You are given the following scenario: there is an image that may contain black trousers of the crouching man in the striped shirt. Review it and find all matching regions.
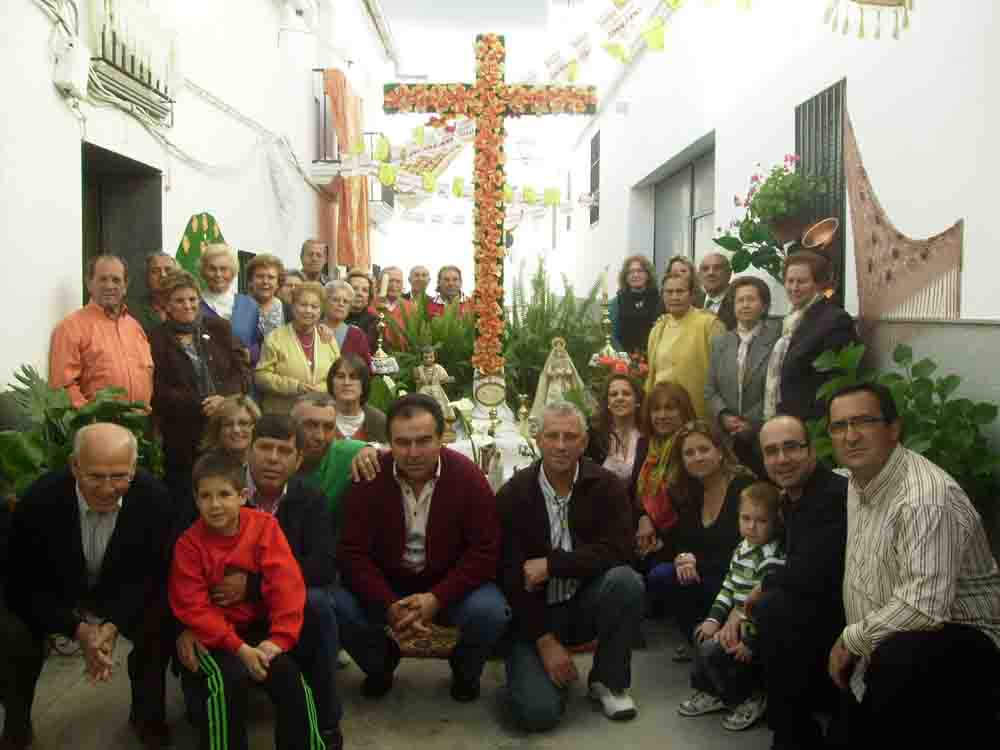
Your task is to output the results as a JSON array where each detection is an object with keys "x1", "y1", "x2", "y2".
[{"x1": 831, "y1": 624, "x2": 1000, "y2": 749}]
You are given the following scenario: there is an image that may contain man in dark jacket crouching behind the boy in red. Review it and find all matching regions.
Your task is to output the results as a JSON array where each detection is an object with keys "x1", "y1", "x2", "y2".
[{"x1": 179, "y1": 414, "x2": 343, "y2": 750}]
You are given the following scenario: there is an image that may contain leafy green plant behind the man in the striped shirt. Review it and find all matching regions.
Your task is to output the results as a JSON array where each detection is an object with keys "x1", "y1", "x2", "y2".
[{"x1": 809, "y1": 344, "x2": 1000, "y2": 504}]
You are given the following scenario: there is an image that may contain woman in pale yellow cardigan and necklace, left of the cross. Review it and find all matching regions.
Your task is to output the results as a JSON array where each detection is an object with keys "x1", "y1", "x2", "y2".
[{"x1": 254, "y1": 282, "x2": 340, "y2": 414}]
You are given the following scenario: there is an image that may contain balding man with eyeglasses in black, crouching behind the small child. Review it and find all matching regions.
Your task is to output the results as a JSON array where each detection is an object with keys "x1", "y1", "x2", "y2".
[{"x1": 746, "y1": 416, "x2": 847, "y2": 750}]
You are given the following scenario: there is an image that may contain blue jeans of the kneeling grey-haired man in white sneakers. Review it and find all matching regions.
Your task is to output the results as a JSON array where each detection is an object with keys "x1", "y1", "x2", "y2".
[{"x1": 507, "y1": 565, "x2": 644, "y2": 732}]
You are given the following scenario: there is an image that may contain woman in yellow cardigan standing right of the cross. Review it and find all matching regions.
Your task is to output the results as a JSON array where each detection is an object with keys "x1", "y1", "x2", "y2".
[{"x1": 646, "y1": 273, "x2": 726, "y2": 419}]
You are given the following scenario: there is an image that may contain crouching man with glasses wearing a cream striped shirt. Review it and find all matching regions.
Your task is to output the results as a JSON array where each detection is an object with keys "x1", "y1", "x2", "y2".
[{"x1": 828, "y1": 384, "x2": 1000, "y2": 747}]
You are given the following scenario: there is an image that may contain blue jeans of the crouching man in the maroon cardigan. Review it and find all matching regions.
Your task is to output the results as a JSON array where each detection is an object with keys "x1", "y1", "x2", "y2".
[{"x1": 334, "y1": 583, "x2": 510, "y2": 682}]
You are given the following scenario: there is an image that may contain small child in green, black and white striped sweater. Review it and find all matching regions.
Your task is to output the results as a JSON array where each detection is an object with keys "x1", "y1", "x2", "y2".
[{"x1": 677, "y1": 482, "x2": 784, "y2": 731}]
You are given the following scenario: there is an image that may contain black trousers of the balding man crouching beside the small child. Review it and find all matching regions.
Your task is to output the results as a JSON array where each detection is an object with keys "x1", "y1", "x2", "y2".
[{"x1": 753, "y1": 589, "x2": 844, "y2": 748}]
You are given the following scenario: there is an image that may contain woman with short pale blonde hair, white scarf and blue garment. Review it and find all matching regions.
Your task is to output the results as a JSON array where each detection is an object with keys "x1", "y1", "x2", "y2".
[{"x1": 199, "y1": 243, "x2": 263, "y2": 364}]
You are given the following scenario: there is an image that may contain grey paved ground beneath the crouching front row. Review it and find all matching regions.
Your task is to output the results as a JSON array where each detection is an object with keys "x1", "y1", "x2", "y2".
[{"x1": 0, "y1": 621, "x2": 770, "y2": 750}]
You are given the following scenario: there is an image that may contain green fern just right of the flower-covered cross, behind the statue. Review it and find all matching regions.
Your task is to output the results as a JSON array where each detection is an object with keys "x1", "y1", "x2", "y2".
[{"x1": 504, "y1": 259, "x2": 604, "y2": 410}]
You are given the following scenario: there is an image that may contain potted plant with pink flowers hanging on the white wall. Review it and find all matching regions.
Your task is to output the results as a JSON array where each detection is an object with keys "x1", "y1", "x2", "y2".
[{"x1": 715, "y1": 154, "x2": 826, "y2": 282}]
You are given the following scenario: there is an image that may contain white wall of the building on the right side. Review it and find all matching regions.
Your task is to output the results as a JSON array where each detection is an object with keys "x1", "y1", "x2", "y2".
[{"x1": 572, "y1": 0, "x2": 1000, "y2": 319}]
